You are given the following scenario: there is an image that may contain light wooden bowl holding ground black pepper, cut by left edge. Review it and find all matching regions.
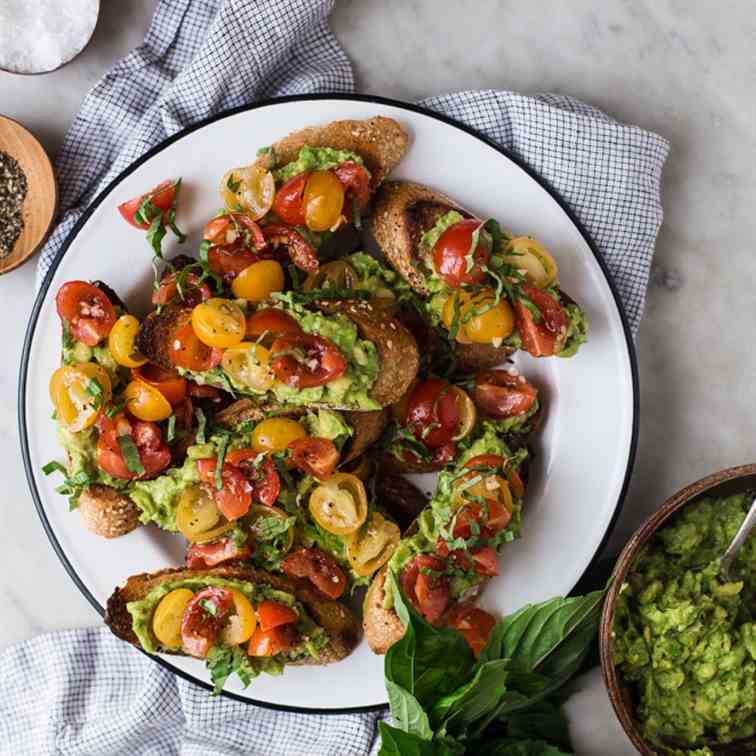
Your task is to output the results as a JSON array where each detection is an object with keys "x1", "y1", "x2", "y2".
[{"x1": 0, "y1": 116, "x2": 58, "y2": 274}]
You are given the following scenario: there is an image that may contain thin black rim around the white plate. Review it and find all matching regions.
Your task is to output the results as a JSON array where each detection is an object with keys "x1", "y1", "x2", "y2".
[{"x1": 18, "y1": 93, "x2": 640, "y2": 714}]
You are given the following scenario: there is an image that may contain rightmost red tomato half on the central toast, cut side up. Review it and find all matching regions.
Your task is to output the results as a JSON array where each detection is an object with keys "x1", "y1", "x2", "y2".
[{"x1": 270, "y1": 333, "x2": 347, "y2": 389}]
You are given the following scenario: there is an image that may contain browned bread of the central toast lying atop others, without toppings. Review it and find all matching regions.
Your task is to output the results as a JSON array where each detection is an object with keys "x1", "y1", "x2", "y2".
[{"x1": 136, "y1": 300, "x2": 420, "y2": 410}]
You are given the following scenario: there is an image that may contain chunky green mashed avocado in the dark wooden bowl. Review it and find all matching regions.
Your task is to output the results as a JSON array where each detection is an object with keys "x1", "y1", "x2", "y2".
[{"x1": 614, "y1": 494, "x2": 756, "y2": 754}]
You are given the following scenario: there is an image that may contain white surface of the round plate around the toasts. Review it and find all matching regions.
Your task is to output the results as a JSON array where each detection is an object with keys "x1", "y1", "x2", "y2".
[{"x1": 19, "y1": 97, "x2": 637, "y2": 711}]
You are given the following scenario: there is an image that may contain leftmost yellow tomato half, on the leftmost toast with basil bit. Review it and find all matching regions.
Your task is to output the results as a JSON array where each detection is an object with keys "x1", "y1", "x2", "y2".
[{"x1": 50, "y1": 362, "x2": 113, "y2": 432}]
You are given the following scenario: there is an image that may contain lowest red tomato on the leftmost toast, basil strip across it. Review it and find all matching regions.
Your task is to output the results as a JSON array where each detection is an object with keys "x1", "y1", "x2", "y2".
[{"x1": 97, "y1": 412, "x2": 171, "y2": 480}]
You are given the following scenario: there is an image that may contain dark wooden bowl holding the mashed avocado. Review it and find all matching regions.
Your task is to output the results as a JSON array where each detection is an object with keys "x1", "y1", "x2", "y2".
[{"x1": 599, "y1": 464, "x2": 756, "y2": 756}]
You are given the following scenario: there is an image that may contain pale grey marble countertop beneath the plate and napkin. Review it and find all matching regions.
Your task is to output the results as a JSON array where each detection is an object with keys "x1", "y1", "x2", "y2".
[{"x1": 0, "y1": 0, "x2": 756, "y2": 756}]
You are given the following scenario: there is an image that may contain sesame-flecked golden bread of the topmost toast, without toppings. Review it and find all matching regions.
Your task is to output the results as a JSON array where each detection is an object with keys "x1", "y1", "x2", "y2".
[{"x1": 255, "y1": 116, "x2": 409, "y2": 191}]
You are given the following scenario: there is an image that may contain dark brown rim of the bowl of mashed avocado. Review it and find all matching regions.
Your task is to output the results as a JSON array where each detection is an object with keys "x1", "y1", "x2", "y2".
[{"x1": 599, "y1": 464, "x2": 756, "y2": 756}]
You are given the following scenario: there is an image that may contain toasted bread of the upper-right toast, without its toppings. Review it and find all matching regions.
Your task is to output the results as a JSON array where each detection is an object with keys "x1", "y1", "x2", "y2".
[{"x1": 369, "y1": 181, "x2": 512, "y2": 370}]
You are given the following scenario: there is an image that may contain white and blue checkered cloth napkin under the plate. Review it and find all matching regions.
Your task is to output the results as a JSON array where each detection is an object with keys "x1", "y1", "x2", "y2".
[{"x1": 13, "y1": 0, "x2": 669, "y2": 756}]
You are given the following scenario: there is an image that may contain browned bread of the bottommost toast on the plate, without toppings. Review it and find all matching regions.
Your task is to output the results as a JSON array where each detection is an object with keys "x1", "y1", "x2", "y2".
[{"x1": 105, "y1": 565, "x2": 359, "y2": 664}]
